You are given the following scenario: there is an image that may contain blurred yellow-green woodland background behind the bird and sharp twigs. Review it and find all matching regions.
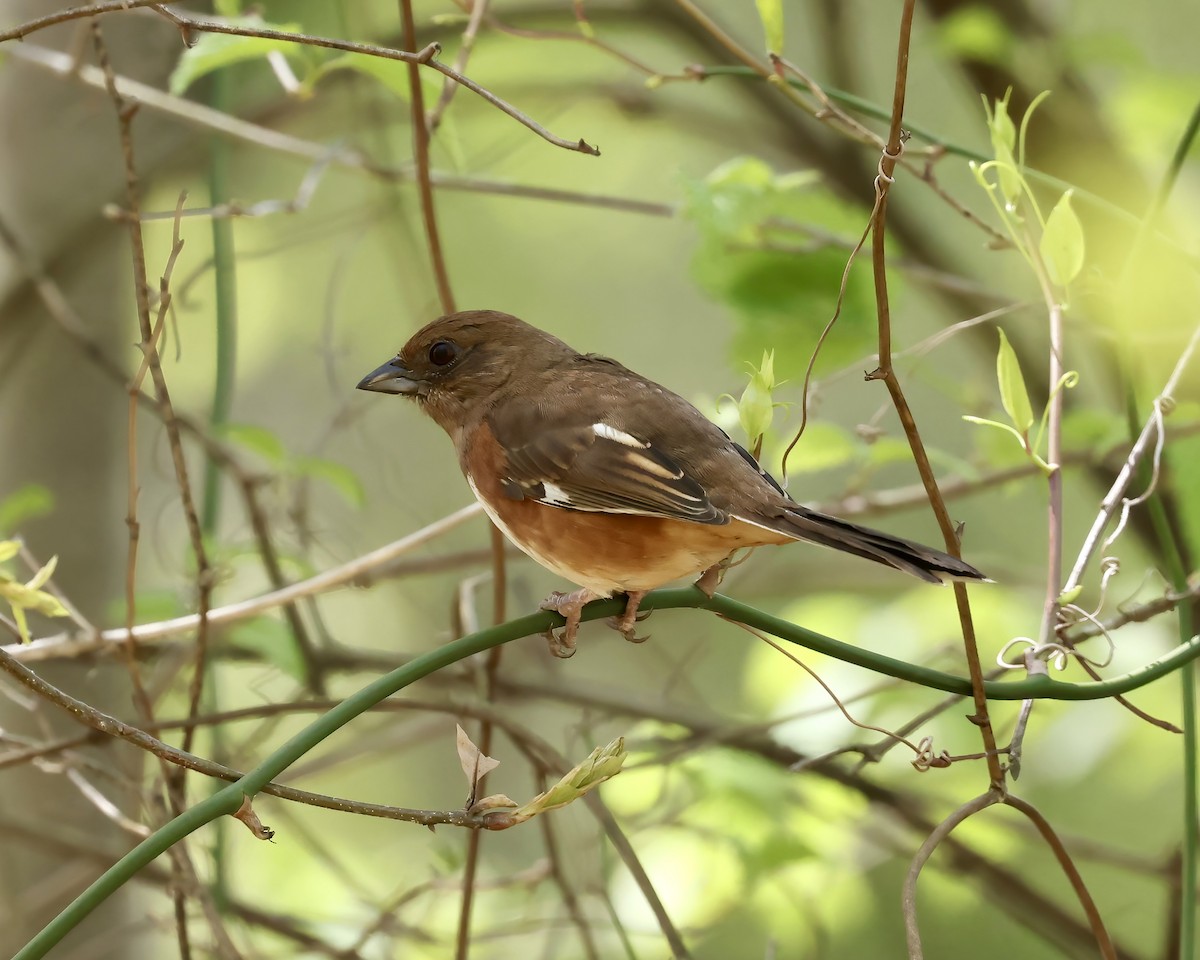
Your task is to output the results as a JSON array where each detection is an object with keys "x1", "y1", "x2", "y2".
[{"x1": 0, "y1": 0, "x2": 1200, "y2": 960}]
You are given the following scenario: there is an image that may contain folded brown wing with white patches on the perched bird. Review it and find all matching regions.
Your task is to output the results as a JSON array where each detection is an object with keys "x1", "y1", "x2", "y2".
[{"x1": 493, "y1": 421, "x2": 728, "y2": 523}]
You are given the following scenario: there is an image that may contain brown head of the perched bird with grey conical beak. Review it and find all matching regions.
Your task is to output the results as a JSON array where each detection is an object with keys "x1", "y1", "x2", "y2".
[{"x1": 359, "y1": 310, "x2": 575, "y2": 433}]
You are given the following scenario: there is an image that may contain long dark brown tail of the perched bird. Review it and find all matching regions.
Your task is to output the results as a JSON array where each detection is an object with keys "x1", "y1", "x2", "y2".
[{"x1": 772, "y1": 506, "x2": 991, "y2": 583}]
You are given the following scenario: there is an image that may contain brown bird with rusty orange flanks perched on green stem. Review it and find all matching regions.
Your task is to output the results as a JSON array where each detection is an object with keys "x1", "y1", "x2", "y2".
[{"x1": 358, "y1": 310, "x2": 988, "y2": 656}]
